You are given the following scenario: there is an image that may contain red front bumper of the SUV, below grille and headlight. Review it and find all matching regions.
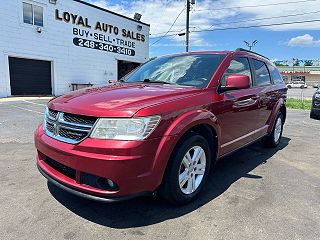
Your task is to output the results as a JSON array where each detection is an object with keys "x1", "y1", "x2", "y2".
[{"x1": 35, "y1": 126, "x2": 168, "y2": 199}]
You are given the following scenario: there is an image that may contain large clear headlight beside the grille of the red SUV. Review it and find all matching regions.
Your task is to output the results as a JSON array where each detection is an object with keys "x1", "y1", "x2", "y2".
[{"x1": 90, "y1": 116, "x2": 161, "y2": 141}]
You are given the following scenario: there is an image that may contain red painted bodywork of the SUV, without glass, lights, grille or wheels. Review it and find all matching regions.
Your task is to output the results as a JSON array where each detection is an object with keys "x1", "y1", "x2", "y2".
[{"x1": 35, "y1": 51, "x2": 287, "y2": 199}]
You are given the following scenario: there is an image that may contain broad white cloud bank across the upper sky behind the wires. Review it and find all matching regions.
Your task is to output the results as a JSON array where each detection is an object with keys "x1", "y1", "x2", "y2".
[{"x1": 87, "y1": 0, "x2": 320, "y2": 49}]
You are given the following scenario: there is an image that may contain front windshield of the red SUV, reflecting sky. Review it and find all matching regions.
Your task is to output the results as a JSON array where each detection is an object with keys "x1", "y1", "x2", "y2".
[{"x1": 121, "y1": 54, "x2": 226, "y2": 88}]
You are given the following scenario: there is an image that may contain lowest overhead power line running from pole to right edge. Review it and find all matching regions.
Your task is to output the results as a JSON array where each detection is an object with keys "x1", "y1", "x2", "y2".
[{"x1": 150, "y1": 19, "x2": 320, "y2": 41}]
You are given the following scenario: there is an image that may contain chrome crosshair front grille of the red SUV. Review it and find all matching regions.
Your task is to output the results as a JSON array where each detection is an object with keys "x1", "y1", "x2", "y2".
[{"x1": 43, "y1": 109, "x2": 97, "y2": 144}]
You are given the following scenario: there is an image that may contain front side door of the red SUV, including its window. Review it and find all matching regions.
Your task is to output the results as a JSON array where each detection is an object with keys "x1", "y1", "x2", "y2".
[{"x1": 214, "y1": 57, "x2": 259, "y2": 155}]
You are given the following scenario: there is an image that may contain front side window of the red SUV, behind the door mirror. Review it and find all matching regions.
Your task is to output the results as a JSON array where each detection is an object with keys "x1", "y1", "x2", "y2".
[{"x1": 220, "y1": 57, "x2": 251, "y2": 86}]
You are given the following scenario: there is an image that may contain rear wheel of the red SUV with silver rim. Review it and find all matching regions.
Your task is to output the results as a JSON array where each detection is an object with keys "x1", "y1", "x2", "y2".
[{"x1": 262, "y1": 112, "x2": 284, "y2": 148}]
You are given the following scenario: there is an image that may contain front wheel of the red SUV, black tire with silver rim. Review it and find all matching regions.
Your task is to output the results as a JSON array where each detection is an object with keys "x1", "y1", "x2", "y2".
[{"x1": 160, "y1": 134, "x2": 211, "y2": 205}]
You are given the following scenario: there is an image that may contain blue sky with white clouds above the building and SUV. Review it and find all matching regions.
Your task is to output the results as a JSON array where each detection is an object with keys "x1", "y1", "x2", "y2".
[{"x1": 86, "y1": 0, "x2": 320, "y2": 60}]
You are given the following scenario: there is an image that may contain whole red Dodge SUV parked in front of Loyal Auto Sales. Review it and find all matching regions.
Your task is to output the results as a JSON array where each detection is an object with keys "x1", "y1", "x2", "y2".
[{"x1": 35, "y1": 49, "x2": 287, "y2": 204}]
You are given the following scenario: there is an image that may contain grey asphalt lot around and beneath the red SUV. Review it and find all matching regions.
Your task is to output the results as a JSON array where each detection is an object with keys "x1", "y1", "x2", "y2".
[{"x1": 0, "y1": 100, "x2": 320, "y2": 240}]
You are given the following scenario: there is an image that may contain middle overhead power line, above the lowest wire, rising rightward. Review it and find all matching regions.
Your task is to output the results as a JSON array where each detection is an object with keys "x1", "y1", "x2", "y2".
[{"x1": 150, "y1": 11, "x2": 320, "y2": 38}]
